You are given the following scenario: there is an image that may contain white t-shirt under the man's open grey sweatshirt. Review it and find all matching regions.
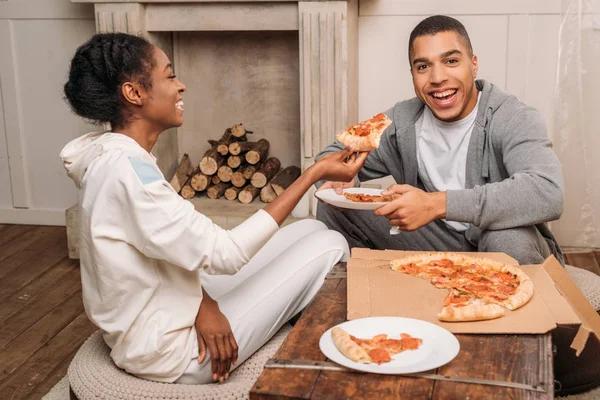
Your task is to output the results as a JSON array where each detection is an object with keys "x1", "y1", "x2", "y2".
[{"x1": 416, "y1": 93, "x2": 481, "y2": 232}]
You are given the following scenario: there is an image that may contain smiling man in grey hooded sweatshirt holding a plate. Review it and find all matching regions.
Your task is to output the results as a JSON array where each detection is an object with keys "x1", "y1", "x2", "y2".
[{"x1": 316, "y1": 16, "x2": 564, "y2": 264}]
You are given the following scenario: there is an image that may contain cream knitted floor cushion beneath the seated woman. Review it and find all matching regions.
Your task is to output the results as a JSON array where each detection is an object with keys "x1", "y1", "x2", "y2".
[{"x1": 68, "y1": 324, "x2": 292, "y2": 400}]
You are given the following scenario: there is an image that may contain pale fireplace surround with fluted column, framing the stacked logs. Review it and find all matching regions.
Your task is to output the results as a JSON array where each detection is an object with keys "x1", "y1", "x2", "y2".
[{"x1": 71, "y1": 0, "x2": 358, "y2": 217}]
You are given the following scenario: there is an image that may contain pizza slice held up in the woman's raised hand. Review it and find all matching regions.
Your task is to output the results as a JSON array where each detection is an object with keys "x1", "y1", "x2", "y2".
[{"x1": 336, "y1": 114, "x2": 392, "y2": 151}]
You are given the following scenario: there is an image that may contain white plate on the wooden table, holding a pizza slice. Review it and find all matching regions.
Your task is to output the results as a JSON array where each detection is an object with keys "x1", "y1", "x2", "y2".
[{"x1": 319, "y1": 317, "x2": 460, "y2": 374}]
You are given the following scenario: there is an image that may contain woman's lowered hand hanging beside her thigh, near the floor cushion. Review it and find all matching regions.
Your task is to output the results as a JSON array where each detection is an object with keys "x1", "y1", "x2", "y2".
[{"x1": 195, "y1": 289, "x2": 238, "y2": 382}]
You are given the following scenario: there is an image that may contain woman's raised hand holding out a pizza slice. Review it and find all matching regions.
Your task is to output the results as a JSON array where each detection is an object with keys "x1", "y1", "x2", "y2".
[{"x1": 311, "y1": 147, "x2": 369, "y2": 182}]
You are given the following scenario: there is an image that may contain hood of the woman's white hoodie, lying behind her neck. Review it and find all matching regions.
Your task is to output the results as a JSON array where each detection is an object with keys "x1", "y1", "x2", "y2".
[{"x1": 60, "y1": 132, "x2": 148, "y2": 188}]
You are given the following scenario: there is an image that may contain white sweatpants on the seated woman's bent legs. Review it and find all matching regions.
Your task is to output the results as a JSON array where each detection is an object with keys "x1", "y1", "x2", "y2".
[{"x1": 176, "y1": 220, "x2": 349, "y2": 384}]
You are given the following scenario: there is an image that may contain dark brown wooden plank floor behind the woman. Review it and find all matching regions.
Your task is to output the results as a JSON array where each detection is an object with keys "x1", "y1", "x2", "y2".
[{"x1": 0, "y1": 225, "x2": 600, "y2": 400}]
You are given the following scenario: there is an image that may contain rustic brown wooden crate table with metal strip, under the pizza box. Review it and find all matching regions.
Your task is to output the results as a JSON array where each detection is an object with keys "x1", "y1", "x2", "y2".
[{"x1": 250, "y1": 264, "x2": 554, "y2": 400}]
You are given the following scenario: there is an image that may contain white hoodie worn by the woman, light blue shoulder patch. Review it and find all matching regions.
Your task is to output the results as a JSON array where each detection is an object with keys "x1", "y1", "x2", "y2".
[{"x1": 60, "y1": 132, "x2": 279, "y2": 382}]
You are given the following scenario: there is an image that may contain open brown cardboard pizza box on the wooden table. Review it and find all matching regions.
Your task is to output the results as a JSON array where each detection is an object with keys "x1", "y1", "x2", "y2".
[{"x1": 347, "y1": 248, "x2": 600, "y2": 353}]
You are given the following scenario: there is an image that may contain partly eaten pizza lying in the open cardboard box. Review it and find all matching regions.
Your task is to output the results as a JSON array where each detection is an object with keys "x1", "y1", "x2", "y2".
[{"x1": 391, "y1": 253, "x2": 533, "y2": 322}]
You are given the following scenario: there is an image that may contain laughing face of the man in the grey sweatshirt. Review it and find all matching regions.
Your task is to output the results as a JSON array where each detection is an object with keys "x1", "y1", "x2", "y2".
[{"x1": 410, "y1": 32, "x2": 478, "y2": 122}]
